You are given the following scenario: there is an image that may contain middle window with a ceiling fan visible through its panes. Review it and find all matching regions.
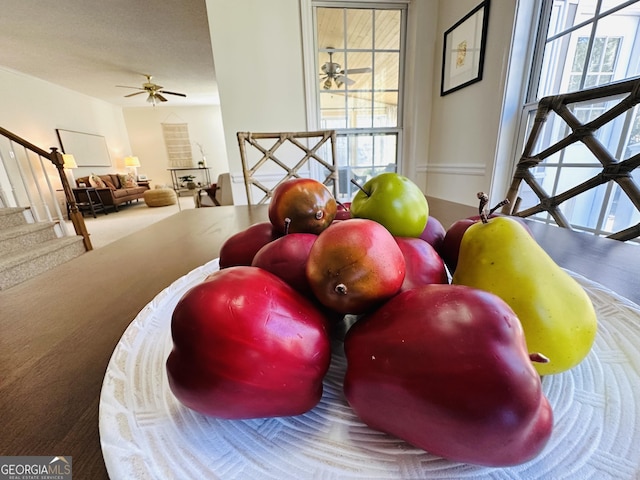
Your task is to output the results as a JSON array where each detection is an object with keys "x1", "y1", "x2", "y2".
[{"x1": 309, "y1": 1, "x2": 406, "y2": 201}]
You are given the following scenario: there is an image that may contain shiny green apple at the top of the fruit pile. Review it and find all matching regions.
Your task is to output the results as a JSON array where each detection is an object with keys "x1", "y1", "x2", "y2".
[{"x1": 351, "y1": 172, "x2": 429, "y2": 237}]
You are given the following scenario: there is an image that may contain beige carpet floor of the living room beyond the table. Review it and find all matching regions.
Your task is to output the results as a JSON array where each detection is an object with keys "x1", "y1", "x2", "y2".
[{"x1": 66, "y1": 197, "x2": 195, "y2": 249}]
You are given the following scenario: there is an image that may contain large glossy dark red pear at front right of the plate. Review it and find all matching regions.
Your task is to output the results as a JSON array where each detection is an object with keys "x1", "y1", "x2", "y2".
[{"x1": 344, "y1": 285, "x2": 553, "y2": 467}]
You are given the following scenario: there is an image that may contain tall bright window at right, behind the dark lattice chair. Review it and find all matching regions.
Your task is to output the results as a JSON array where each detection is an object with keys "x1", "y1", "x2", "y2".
[{"x1": 519, "y1": 0, "x2": 640, "y2": 240}]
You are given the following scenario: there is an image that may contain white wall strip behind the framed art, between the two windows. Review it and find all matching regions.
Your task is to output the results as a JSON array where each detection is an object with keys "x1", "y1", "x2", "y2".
[{"x1": 425, "y1": 0, "x2": 517, "y2": 205}]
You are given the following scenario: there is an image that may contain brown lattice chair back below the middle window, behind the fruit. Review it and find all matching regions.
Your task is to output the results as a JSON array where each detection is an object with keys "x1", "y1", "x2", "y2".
[{"x1": 237, "y1": 130, "x2": 338, "y2": 204}]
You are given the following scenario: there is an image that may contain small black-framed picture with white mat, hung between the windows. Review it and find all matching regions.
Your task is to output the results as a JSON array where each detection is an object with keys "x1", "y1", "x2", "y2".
[{"x1": 440, "y1": 0, "x2": 490, "y2": 96}]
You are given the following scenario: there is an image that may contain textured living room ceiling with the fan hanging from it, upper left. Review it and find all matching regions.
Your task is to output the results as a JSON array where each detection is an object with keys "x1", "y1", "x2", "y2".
[{"x1": 0, "y1": 0, "x2": 218, "y2": 107}]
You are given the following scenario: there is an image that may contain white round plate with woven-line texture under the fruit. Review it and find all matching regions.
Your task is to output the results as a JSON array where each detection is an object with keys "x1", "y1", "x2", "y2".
[{"x1": 99, "y1": 260, "x2": 640, "y2": 480}]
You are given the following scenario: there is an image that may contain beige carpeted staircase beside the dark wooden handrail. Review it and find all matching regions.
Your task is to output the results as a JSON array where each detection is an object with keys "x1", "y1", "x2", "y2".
[{"x1": 0, "y1": 207, "x2": 86, "y2": 290}]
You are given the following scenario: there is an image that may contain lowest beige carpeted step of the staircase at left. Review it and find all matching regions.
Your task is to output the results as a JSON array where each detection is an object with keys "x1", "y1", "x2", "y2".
[{"x1": 0, "y1": 235, "x2": 85, "y2": 290}]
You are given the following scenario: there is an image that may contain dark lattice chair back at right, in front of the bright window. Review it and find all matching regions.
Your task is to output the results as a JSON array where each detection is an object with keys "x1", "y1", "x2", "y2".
[{"x1": 502, "y1": 78, "x2": 640, "y2": 241}]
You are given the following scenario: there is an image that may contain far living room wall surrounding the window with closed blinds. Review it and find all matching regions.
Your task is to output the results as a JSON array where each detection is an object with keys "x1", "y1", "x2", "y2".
[{"x1": 124, "y1": 105, "x2": 229, "y2": 186}]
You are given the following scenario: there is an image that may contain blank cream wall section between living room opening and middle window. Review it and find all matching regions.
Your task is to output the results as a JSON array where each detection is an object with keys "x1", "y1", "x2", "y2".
[{"x1": 207, "y1": 0, "x2": 306, "y2": 204}]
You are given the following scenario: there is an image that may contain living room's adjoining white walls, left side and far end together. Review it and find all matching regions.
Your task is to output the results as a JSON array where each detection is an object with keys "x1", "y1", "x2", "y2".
[{"x1": 0, "y1": 67, "x2": 229, "y2": 197}]
